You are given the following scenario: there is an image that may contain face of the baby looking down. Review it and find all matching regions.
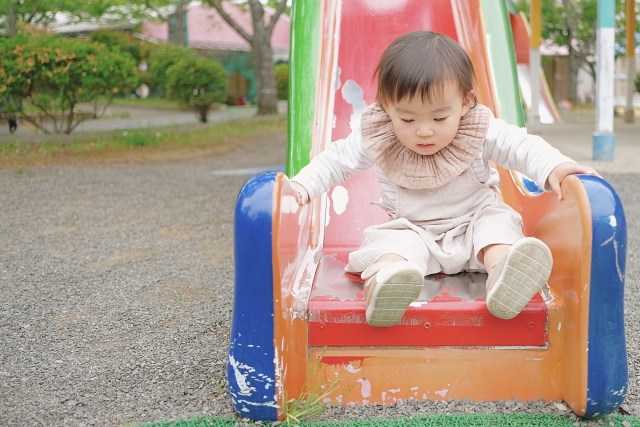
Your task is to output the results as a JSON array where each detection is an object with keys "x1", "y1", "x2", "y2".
[{"x1": 383, "y1": 84, "x2": 475, "y2": 155}]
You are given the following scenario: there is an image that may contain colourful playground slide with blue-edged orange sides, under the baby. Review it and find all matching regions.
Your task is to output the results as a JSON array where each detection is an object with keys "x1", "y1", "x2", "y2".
[{"x1": 228, "y1": 0, "x2": 627, "y2": 420}]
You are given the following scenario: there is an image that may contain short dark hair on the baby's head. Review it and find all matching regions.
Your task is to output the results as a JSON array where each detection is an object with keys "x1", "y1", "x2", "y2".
[{"x1": 374, "y1": 31, "x2": 476, "y2": 104}]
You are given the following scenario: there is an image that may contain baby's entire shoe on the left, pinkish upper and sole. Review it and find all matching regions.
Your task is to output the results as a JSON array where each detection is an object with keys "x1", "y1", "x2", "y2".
[{"x1": 362, "y1": 254, "x2": 424, "y2": 326}]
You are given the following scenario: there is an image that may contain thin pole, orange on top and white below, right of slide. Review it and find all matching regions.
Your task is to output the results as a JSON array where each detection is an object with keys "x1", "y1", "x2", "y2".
[{"x1": 527, "y1": 0, "x2": 542, "y2": 133}]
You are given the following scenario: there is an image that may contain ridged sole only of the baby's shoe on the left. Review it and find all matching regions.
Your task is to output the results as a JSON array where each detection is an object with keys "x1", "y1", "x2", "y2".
[{"x1": 366, "y1": 262, "x2": 424, "y2": 326}]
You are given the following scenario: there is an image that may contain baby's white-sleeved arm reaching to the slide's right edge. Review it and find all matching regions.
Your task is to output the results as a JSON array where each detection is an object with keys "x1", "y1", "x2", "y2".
[{"x1": 482, "y1": 117, "x2": 599, "y2": 197}]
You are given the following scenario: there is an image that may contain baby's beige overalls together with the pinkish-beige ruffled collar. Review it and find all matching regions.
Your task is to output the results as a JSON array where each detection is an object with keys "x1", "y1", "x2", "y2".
[{"x1": 345, "y1": 106, "x2": 524, "y2": 275}]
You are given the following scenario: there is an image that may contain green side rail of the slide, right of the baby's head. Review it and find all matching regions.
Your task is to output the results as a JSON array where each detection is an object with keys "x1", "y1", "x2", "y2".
[{"x1": 480, "y1": 0, "x2": 524, "y2": 126}]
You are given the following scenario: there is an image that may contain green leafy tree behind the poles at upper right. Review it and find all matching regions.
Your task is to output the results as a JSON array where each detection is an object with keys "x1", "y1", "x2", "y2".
[{"x1": 516, "y1": 0, "x2": 638, "y2": 102}]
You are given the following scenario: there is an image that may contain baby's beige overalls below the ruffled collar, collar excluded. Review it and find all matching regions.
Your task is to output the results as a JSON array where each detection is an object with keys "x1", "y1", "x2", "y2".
[{"x1": 346, "y1": 169, "x2": 524, "y2": 275}]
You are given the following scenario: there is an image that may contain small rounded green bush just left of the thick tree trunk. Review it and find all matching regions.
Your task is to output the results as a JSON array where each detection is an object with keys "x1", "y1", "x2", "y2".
[{"x1": 167, "y1": 58, "x2": 229, "y2": 122}]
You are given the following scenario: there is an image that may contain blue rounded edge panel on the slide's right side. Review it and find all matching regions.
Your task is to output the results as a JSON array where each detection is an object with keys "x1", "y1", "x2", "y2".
[{"x1": 579, "y1": 175, "x2": 628, "y2": 417}]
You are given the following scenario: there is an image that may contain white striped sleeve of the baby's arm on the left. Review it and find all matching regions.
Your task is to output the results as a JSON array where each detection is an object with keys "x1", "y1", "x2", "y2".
[{"x1": 291, "y1": 128, "x2": 373, "y2": 206}]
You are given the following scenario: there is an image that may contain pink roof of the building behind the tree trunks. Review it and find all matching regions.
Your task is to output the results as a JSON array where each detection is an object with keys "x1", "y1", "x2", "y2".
[{"x1": 142, "y1": 2, "x2": 291, "y2": 60}]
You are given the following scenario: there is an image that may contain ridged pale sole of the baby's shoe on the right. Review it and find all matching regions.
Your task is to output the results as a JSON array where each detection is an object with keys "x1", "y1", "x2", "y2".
[{"x1": 487, "y1": 237, "x2": 553, "y2": 319}]
